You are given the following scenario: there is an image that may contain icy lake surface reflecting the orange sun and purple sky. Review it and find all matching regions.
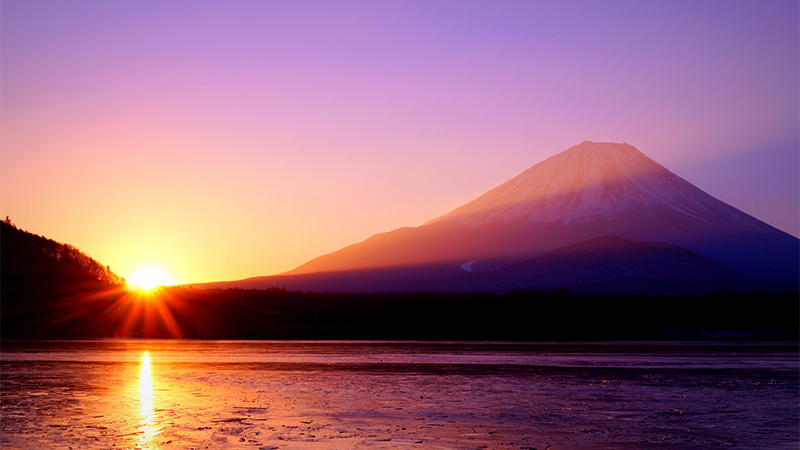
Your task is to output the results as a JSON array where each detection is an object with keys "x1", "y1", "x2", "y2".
[{"x1": 0, "y1": 340, "x2": 800, "y2": 450}]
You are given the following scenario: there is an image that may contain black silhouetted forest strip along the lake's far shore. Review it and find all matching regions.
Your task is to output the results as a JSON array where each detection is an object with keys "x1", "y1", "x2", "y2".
[{"x1": 2, "y1": 287, "x2": 800, "y2": 341}]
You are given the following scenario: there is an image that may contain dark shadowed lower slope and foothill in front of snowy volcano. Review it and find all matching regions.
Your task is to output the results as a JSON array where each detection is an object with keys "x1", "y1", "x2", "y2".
[{"x1": 188, "y1": 236, "x2": 780, "y2": 296}]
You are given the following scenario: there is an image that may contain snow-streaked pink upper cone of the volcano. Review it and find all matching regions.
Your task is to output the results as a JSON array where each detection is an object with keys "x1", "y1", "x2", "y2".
[{"x1": 427, "y1": 141, "x2": 752, "y2": 228}]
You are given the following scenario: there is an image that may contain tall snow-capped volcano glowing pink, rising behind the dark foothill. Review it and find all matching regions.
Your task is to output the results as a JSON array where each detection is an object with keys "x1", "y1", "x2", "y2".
[{"x1": 197, "y1": 142, "x2": 800, "y2": 291}]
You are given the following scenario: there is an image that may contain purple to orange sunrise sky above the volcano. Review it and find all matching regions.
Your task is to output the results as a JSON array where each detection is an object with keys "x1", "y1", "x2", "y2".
[{"x1": 0, "y1": 0, "x2": 800, "y2": 283}]
